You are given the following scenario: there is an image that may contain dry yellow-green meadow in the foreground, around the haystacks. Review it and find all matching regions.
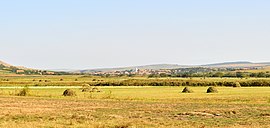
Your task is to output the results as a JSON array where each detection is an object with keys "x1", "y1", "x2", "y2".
[{"x1": 0, "y1": 86, "x2": 270, "y2": 128}]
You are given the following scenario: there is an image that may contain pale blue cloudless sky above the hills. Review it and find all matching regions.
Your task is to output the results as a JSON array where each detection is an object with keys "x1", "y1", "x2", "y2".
[{"x1": 0, "y1": 0, "x2": 270, "y2": 69}]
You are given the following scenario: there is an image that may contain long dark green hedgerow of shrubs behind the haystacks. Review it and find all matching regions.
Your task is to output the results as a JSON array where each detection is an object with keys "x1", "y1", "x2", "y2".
[{"x1": 85, "y1": 79, "x2": 270, "y2": 87}]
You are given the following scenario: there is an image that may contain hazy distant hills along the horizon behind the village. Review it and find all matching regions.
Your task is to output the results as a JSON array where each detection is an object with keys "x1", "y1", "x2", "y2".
[{"x1": 0, "y1": 61, "x2": 270, "y2": 75}]
